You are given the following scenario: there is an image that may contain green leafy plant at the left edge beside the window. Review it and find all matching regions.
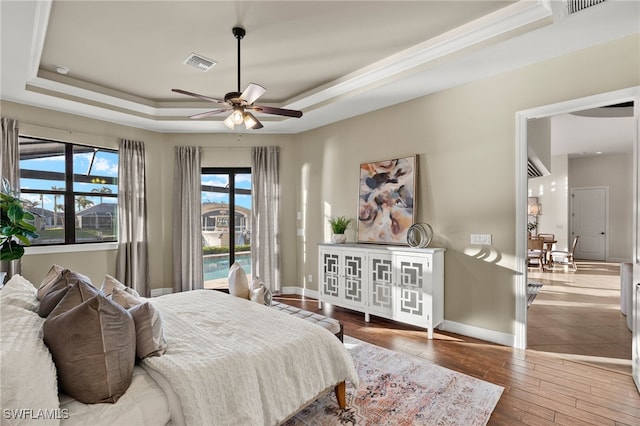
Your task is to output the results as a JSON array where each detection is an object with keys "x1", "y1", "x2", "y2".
[{"x1": 0, "y1": 179, "x2": 38, "y2": 284}]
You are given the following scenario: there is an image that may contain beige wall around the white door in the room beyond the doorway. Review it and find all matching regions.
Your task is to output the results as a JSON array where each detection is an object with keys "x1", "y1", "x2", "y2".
[{"x1": 569, "y1": 153, "x2": 633, "y2": 262}]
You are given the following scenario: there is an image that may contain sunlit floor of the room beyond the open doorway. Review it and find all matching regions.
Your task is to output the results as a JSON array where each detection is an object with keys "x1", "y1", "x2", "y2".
[{"x1": 527, "y1": 261, "x2": 631, "y2": 374}]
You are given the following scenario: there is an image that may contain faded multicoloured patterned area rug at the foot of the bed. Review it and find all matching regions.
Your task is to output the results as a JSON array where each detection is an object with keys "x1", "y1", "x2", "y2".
[{"x1": 285, "y1": 336, "x2": 504, "y2": 426}]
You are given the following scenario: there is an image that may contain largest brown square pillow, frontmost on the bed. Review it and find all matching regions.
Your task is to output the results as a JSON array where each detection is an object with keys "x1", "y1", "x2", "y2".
[{"x1": 44, "y1": 294, "x2": 136, "y2": 404}]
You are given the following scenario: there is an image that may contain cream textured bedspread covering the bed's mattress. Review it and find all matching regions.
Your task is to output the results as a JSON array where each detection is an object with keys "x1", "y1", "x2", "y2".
[{"x1": 142, "y1": 290, "x2": 358, "y2": 425}]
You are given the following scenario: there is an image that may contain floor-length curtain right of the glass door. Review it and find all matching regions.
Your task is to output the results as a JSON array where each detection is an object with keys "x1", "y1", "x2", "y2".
[{"x1": 251, "y1": 146, "x2": 282, "y2": 294}]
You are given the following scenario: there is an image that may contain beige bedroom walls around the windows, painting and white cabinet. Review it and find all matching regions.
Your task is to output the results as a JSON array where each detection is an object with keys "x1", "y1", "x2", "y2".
[{"x1": 1, "y1": 35, "x2": 640, "y2": 335}]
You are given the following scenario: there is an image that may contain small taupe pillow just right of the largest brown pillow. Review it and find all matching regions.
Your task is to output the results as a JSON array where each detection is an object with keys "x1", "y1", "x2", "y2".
[{"x1": 129, "y1": 302, "x2": 167, "y2": 359}]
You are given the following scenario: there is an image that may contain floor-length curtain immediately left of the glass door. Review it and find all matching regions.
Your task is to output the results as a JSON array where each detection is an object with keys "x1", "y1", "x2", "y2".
[{"x1": 173, "y1": 146, "x2": 204, "y2": 293}]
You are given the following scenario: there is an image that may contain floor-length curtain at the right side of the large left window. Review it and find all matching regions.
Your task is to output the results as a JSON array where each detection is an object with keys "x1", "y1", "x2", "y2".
[{"x1": 116, "y1": 139, "x2": 151, "y2": 297}]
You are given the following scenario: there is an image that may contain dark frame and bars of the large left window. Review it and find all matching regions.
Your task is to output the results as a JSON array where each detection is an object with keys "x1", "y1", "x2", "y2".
[{"x1": 19, "y1": 134, "x2": 120, "y2": 248}]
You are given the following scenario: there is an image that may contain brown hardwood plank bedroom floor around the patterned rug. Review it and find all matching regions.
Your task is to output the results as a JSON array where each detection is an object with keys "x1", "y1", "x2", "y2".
[{"x1": 275, "y1": 276, "x2": 640, "y2": 426}]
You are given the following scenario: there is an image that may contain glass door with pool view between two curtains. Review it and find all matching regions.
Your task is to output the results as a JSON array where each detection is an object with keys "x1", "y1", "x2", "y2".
[{"x1": 201, "y1": 167, "x2": 251, "y2": 289}]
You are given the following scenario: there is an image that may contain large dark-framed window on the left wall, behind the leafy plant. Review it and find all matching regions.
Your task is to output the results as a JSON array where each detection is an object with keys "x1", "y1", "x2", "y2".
[{"x1": 19, "y1": 136, "x2": 118, "y2": 245}]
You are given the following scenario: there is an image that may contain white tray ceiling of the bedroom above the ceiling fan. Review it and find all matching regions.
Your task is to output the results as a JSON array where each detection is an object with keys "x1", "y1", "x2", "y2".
[{"x1": 0, "y1": 0, "x2": 640, "y2": 155}]
